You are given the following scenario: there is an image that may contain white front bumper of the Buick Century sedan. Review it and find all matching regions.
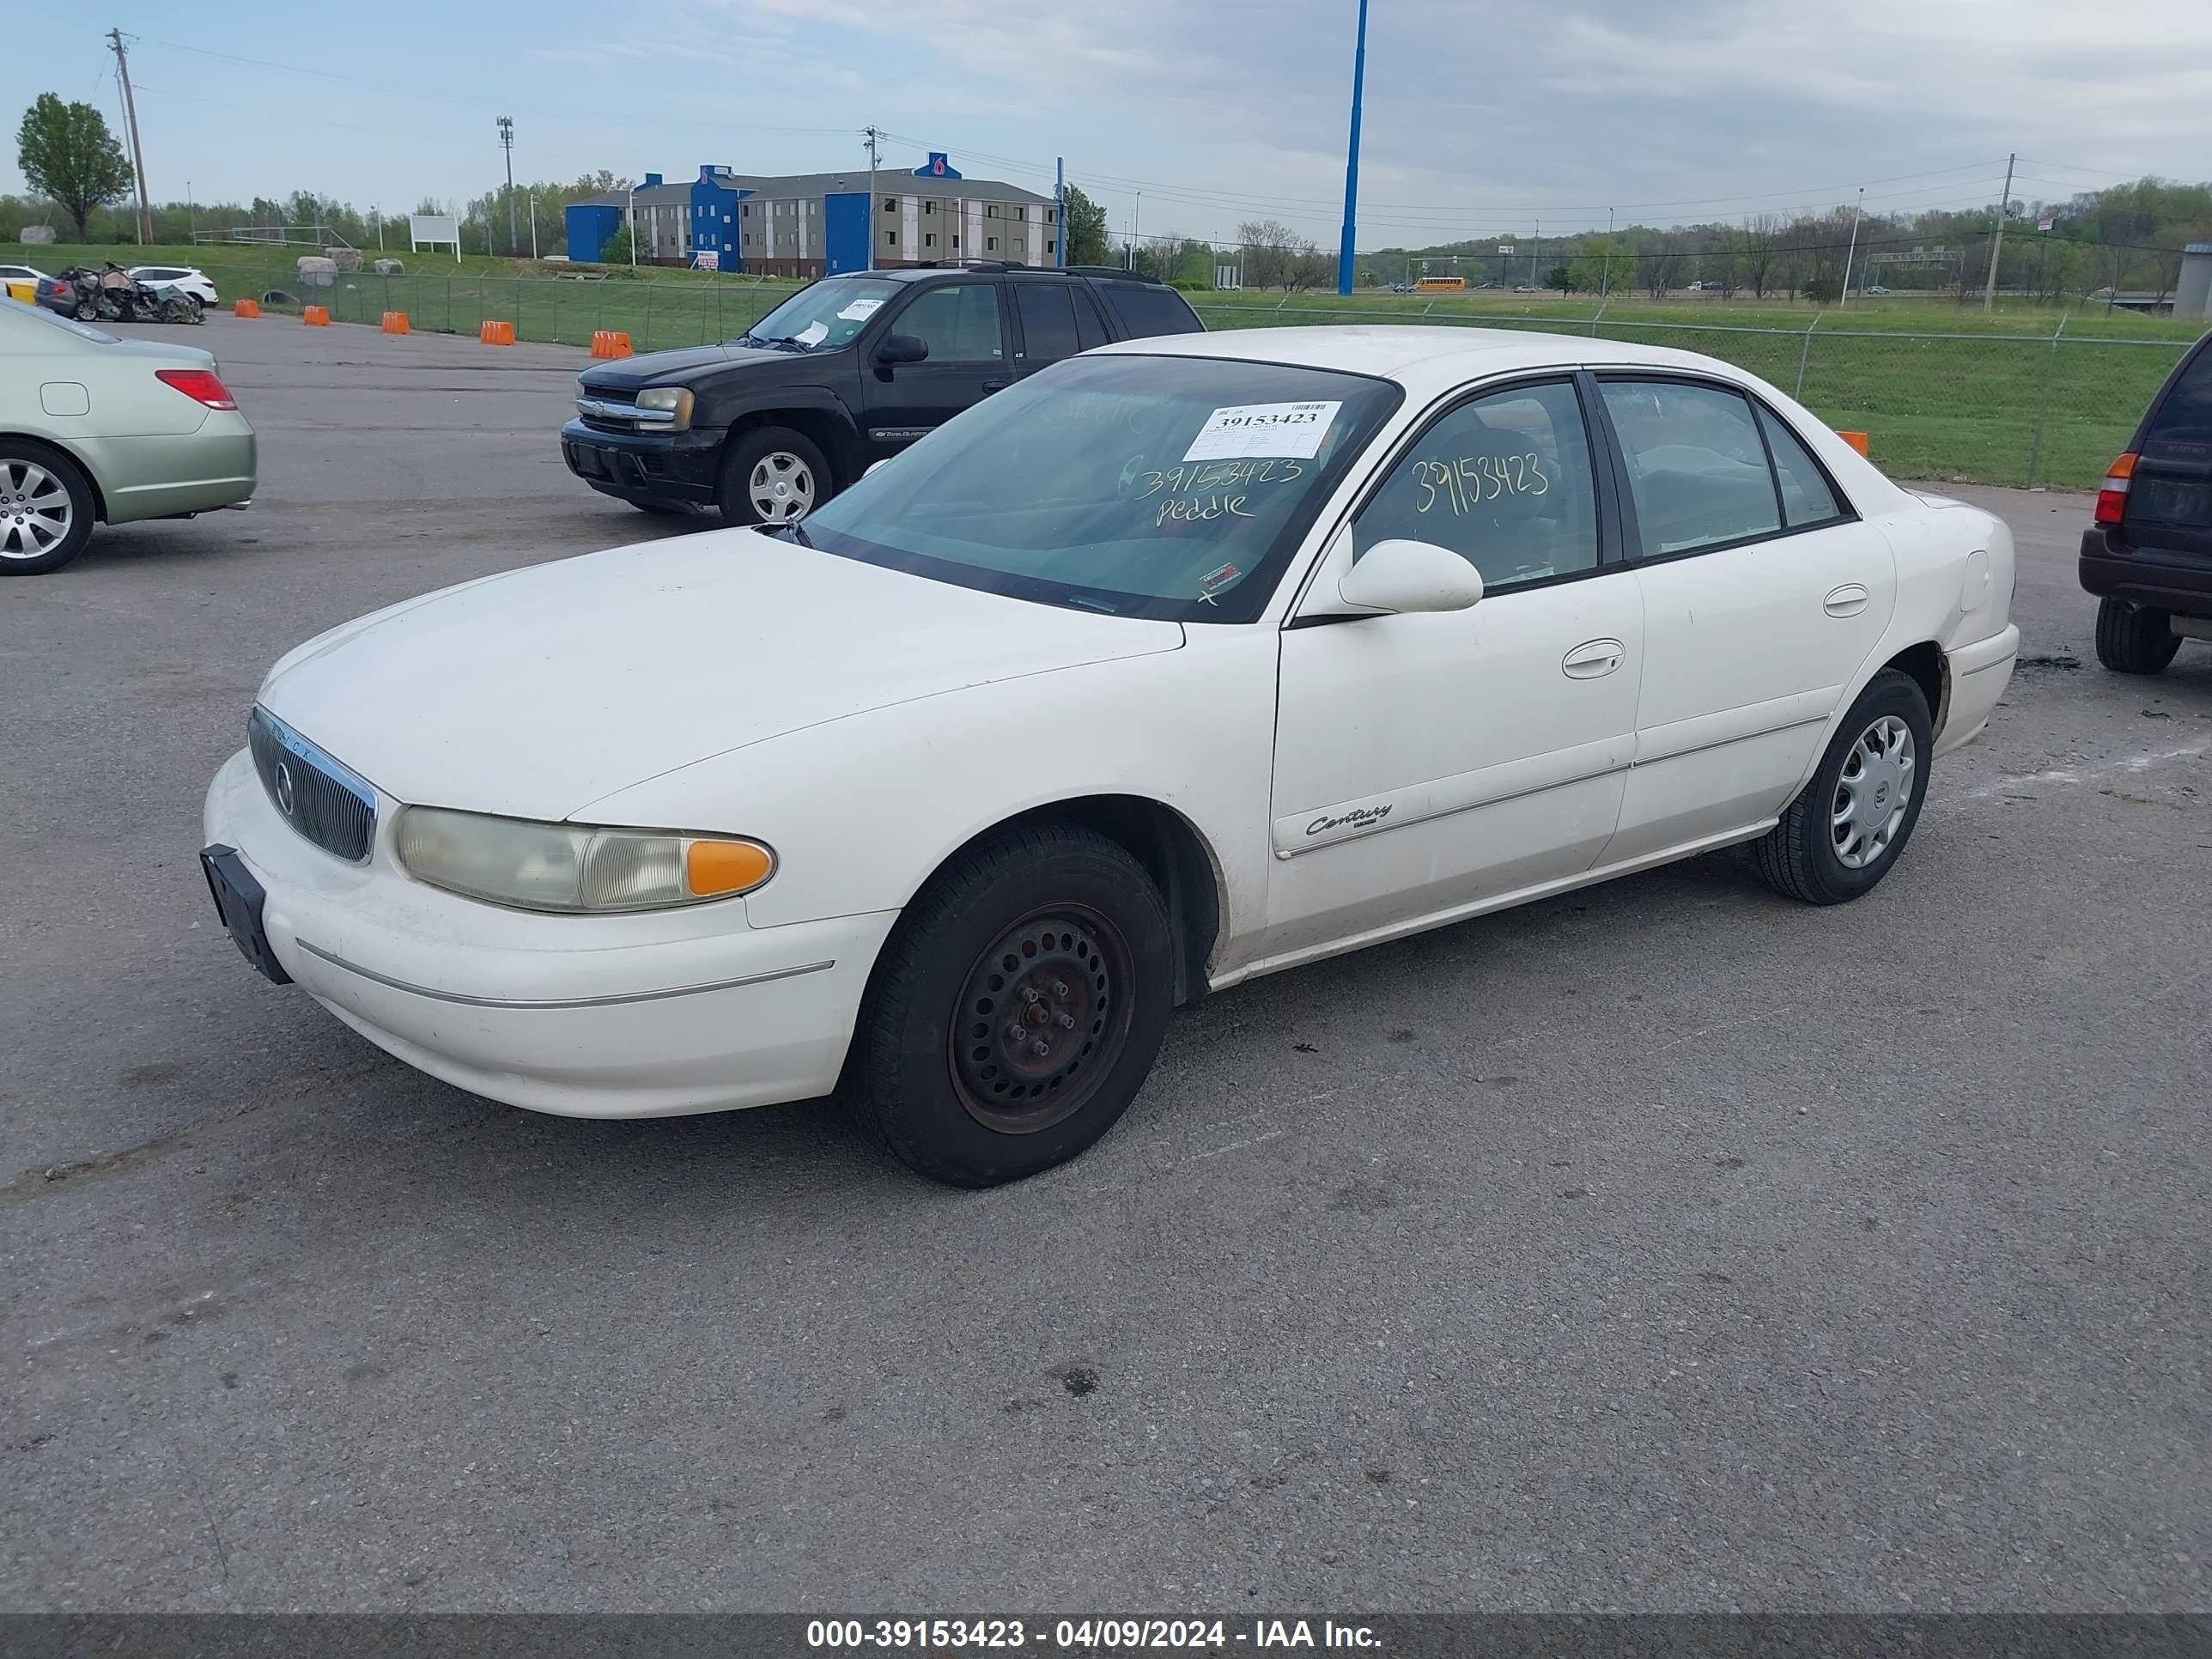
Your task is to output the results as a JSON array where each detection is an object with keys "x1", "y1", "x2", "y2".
[{"x1": 204, "y1": 750, "x2": 896, "y2": 1117}]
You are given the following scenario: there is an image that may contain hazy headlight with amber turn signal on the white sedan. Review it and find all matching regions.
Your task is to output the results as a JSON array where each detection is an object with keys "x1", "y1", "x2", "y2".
[{"x1": 396, "y1": 807, "x2": 776, "y2": 911}]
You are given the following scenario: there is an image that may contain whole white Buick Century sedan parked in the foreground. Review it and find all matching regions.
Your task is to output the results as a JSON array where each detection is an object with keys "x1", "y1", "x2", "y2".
[{"x1": 201, "y1": 327, "x2": 2020, "y2": 1186}]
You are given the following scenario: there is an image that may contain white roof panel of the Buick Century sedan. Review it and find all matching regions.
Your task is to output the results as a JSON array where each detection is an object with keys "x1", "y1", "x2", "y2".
[{"x1": 1097, "y1": 323, "x2": 1778, "y2": 392}]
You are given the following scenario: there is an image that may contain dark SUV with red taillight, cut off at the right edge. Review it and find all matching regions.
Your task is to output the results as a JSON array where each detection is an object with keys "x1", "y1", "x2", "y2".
[{"x1": 2081, "y1": 334, "x2": 2212, "y2": 675}]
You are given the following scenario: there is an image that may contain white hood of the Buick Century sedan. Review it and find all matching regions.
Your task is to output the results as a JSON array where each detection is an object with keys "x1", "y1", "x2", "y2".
[{"x1": 258, "y1": 531, "x2": 1183, "y2": 818}]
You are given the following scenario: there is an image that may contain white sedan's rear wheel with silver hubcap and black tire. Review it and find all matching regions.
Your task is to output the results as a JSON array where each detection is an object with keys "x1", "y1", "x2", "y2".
[{"x1": 1752, "y1": 668, "x2": 1936, "y2": 905}]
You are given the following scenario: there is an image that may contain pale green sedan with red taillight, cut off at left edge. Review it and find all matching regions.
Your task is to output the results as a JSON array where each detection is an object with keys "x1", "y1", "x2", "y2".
[{"x1": 0, "y1": 301, "x2": 254, "y2": 575}]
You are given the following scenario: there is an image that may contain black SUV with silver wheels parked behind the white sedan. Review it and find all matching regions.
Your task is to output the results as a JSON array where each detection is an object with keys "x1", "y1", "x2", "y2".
[{"x1": 560, "y1": 264, "x2": 1206, "y2": 525}]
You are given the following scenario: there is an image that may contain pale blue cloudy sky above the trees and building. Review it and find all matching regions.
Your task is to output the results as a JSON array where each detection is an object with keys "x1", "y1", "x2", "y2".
[{"x1": 0, "y1": 0, "x2": 2212, "y2": 248}]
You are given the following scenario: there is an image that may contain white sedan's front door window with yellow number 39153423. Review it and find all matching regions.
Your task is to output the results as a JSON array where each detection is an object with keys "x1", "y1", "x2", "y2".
[{"x1": 1352, "y1": 380, "x2": 1597, "y2": 591}]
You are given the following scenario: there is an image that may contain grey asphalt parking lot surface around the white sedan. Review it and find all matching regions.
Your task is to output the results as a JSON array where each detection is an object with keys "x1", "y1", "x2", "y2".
[{"x1": 0, "y1": 316, "x2": 2212, "y2": 1614}]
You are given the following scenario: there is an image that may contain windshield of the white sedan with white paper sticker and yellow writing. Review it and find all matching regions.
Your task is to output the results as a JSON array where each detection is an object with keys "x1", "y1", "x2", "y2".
[{"x1": 794, "y1": 356, "x2": 1401, "y2": 622}]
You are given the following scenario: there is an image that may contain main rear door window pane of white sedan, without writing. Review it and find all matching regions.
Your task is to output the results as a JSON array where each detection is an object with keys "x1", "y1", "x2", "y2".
[{"x1": 1601, "y1": 380, "x2": 1781, "y2": 560}]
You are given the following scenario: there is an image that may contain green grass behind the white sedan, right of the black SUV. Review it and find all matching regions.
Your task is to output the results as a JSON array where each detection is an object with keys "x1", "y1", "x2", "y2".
[{"x1": 1197, "y1": 303, "x2": 2190, "y2": 489}]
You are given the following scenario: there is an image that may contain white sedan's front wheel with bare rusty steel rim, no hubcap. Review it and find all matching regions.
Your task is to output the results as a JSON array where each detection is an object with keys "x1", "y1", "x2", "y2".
[{"x1": 848, "y1": 823, "x2": 1175, "y2": 1188}]
